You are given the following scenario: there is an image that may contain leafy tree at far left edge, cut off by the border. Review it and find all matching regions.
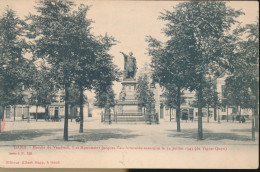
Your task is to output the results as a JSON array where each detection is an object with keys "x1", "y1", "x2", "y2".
[{"x1": 0, "y1": 8, "x2": 34, "y2": 128}]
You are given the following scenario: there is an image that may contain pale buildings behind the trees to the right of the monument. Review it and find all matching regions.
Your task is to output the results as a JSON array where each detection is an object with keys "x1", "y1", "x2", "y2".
[{"x1": 135, "y1": 64, "x2": 252, "y2": 120}]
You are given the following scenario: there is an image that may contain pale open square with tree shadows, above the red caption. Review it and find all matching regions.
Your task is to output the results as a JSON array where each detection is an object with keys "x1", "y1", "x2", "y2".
[{"x1": 0, "y1": 116, "x2": 258, "y2": 146}]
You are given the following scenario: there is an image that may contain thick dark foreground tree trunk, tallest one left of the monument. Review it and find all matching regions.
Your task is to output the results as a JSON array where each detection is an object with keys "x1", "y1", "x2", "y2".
[{"x1": 63, "y1": 85, "x2": 69, "y2": 141}]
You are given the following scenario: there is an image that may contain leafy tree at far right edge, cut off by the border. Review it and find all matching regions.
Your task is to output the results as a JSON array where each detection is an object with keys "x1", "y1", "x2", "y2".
[{"x1": 224, "y1": 21, "x2": 259, "y2": 129}]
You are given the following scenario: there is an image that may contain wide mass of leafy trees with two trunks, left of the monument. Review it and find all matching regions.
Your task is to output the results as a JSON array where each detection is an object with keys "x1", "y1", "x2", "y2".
[{"x1": 0, "y1": 0, "x2": 118, "y2": 141}]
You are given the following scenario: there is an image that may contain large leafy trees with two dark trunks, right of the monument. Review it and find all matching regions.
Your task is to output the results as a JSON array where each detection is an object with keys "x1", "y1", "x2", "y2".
[{"x1": 147, "y1": 1, "x2": 259, "y2": 140}]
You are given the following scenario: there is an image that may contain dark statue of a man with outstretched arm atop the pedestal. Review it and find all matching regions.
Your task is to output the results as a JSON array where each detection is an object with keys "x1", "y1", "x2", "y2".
[{"x1": 120, "y1": 52, "x2": 137, "y2": 79}]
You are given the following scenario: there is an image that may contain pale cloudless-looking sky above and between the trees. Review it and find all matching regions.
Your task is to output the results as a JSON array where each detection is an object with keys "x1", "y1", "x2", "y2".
[{"x1": 0, "y1": 0, "x2": 258, "y2": 98}]
